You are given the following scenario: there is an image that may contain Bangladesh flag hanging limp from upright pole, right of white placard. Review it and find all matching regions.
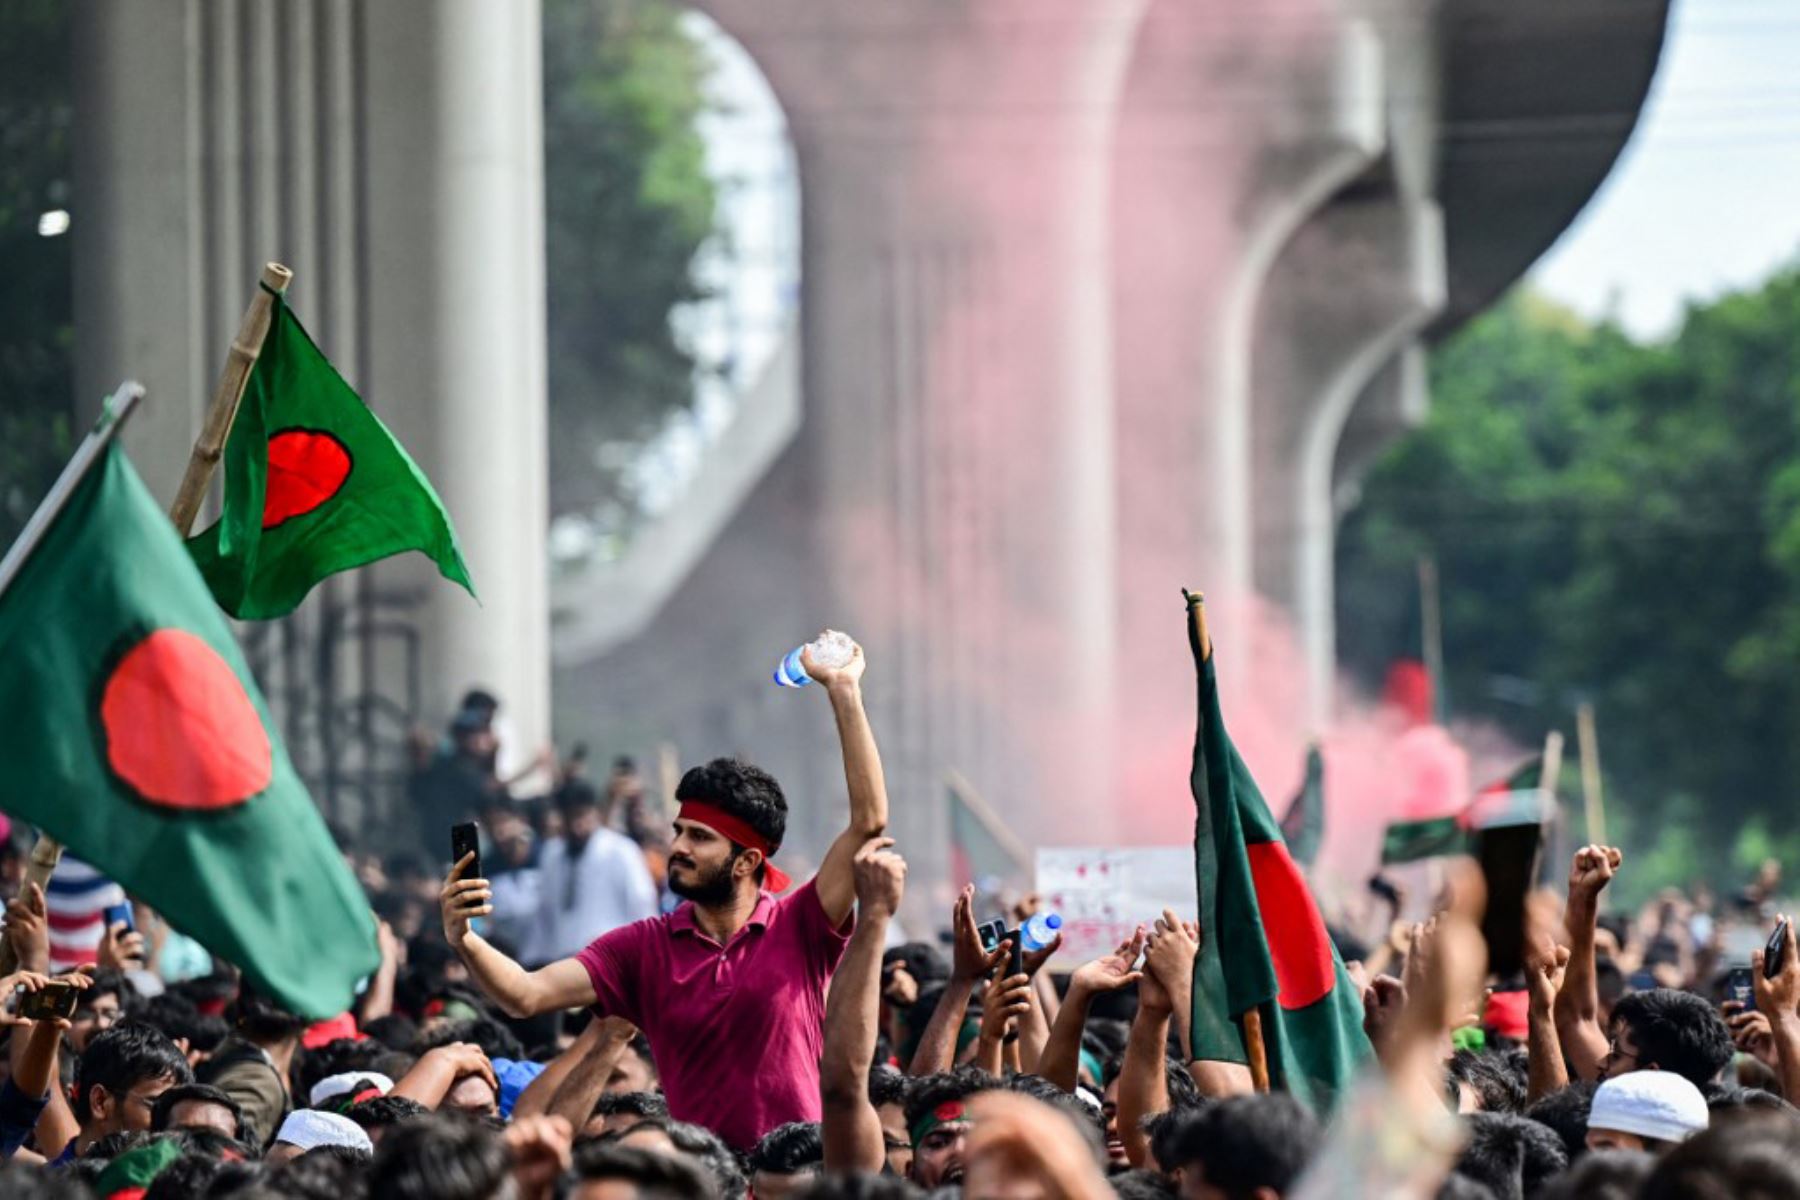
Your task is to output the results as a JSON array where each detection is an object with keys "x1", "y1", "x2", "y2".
[{"x1": 1188, "y1": 596, "x2": 1373, "y2": 1114}]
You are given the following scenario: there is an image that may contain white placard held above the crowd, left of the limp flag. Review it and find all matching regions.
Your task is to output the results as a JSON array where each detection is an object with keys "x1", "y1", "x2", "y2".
[{"x1": 1037, "y1": 846, "x2": 1199, "y2": 968}]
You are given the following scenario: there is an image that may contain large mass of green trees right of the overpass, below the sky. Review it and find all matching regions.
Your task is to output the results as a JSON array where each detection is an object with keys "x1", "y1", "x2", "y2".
[{"x1": 1337, "y1": 270, "x2": 1800, "y2": 888}]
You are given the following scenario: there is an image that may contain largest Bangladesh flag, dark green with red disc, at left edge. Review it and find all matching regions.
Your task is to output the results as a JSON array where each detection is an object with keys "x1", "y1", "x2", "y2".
[{"x1": 0, "y1": 444, "x2": 380, "y2": 1018}]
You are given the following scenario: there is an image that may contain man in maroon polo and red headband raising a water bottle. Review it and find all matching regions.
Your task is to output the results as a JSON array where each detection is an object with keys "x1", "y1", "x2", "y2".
[{"x1": 441, "y1": 646, "x2": 887, "y2": 1150}]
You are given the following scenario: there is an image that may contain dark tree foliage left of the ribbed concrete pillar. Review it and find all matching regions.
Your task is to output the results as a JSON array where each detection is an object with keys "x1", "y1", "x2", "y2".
[{"x1": 0, "y1": 0, "x2": 74, "y2": 547}]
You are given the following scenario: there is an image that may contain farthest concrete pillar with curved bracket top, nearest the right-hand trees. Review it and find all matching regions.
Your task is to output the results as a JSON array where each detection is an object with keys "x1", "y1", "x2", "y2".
[{"x1": 1255, "y1": 195, "x2": 1445, "y2": 729}]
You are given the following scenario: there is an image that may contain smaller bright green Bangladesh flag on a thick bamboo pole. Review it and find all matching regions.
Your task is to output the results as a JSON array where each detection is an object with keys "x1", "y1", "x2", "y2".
[{"x1": 187, "y1": 295, "x2": 475, "y2": 621}]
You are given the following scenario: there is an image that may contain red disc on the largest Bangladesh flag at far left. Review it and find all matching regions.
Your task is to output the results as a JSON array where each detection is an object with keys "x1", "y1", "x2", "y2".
[{"x1": 101, "y1": 630, "x2": 275, "y2": 811}]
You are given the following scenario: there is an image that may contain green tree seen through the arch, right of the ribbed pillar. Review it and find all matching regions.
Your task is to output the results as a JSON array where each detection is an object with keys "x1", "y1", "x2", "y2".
[{"x1": 544, "y1": 0, "x2": 715, "y2": 511}]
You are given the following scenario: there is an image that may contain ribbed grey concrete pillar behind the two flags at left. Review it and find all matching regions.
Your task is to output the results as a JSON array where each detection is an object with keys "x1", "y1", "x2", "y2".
[{"x1": 72, "y1": 0, "x2": 549, "y2": 798}]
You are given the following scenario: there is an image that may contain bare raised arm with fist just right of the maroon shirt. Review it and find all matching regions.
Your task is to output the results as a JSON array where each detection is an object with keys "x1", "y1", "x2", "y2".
[{"x1": 819, "y1": 838, "x2": 905, "y2": 1175}]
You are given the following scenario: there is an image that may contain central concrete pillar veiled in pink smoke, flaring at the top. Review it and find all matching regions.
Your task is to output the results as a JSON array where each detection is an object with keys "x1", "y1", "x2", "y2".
[{"x1": 680, "y1": 0, "x2": 1139, "y2": 835}]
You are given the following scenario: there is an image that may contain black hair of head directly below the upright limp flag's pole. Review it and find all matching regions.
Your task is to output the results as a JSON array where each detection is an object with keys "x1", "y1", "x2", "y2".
[{"x1": 1168, "y1": 1092, "x2": 1323, "y2": 1200}]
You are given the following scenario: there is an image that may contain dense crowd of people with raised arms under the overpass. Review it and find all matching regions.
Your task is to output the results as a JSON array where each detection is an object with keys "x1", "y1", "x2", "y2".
[{"x1": 0, "y1": 651, "x2": 1800, "y2": 1200}]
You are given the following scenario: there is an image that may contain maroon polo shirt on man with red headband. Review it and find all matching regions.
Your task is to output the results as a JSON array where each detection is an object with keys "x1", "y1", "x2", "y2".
[{"x1": 576, "y1": 882, "x2": 855, "y2": 1150}]
